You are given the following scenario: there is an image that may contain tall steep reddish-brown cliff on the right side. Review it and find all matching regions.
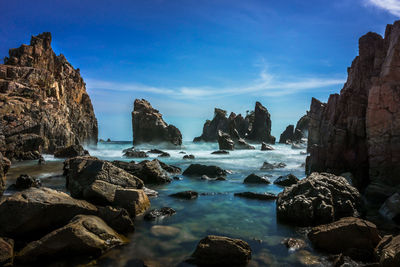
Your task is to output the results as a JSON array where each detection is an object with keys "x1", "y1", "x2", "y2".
[{"x1": 306, "y1": 22, "x2": 400, "y2": 196}]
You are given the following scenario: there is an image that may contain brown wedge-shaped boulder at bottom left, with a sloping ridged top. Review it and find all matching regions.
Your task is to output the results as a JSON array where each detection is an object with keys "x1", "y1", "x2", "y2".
[{"x1": 16, "y1": 215, "x2": 126, "y2": 263}]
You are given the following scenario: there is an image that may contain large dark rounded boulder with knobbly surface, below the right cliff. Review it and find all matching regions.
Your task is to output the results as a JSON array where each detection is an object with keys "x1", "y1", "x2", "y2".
[{"x1": 276, "y1": 173, "x2": 361, "y2": 226}]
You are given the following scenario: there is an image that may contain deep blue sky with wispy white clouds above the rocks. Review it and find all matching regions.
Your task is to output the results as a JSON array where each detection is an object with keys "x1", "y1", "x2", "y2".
[{"x1": 0, "y1": 0, "x2": 400, "y2": 140}]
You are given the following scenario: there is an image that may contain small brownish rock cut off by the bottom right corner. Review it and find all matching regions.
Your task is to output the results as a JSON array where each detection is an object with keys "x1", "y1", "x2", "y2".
[{"x1": 375, "y1": 235, "x2": 400, "y2": 267}]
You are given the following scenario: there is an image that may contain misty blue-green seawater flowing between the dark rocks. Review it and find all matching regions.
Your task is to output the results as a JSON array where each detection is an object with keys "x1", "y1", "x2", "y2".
[{"x1": 6, "y1": 142, "x2": 325, "y2": 266}]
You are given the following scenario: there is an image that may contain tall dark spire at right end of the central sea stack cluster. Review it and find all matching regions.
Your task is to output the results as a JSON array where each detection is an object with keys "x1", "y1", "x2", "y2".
[{"x1": 247, "y1": 102, "x2": 275, "y2": 144}]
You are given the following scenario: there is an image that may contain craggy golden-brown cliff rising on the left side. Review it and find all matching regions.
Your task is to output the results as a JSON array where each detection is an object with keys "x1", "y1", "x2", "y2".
[{"x1": 0, "y1": 33, "x2": 98, "y2": 159}]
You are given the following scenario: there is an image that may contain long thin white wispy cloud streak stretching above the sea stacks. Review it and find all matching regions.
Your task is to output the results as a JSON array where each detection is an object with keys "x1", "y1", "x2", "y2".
[{"x1": 86, "y1": 69, "x2": 345, "y2": 99}]
